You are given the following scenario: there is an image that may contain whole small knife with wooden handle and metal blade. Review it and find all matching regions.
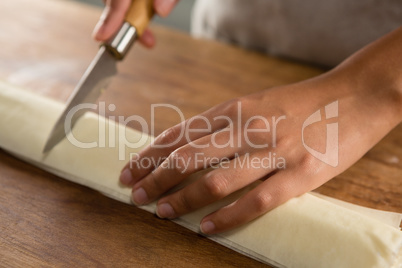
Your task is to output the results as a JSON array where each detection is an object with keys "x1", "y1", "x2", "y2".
[{"x1": 43, "y1": 0, "x2": 154, "y2": 154}]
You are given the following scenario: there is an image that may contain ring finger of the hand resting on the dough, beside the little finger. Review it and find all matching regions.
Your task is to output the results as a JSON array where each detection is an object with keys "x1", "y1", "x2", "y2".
[{"x1": 157, "y1": 152, "x2": 275, "y2": 218}]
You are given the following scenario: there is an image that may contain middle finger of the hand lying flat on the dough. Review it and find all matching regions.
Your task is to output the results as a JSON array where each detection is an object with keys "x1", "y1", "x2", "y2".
[{"x1": 133, "y1": 131, "x2": 242, "y2": 205}]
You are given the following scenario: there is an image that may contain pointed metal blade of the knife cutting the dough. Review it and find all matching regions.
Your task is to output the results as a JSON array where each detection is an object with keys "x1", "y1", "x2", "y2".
[{"x1": 43, "y1": 46, "x2": 117, "y2": 153}]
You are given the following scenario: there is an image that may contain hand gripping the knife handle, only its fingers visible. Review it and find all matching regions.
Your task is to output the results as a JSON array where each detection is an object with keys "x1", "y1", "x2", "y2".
[{"x1": 93, "y1": 0, "x2": 178, "y2": 48}]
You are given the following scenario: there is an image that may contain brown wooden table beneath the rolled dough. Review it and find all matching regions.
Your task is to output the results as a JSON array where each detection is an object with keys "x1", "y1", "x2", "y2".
[{"x1": 0, "y1": 0, "x2": 402, "y2": 267}]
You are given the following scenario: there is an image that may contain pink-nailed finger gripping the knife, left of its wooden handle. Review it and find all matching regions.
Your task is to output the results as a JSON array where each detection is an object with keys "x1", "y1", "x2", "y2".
[{"x1": 93, "y1": 0, "x2": 131, "y2": 41}]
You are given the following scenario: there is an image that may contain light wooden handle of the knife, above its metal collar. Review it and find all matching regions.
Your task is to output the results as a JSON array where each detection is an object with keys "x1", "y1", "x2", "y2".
[{"x1": 125, "y1": 0, "x2": 155, "y2": 36}]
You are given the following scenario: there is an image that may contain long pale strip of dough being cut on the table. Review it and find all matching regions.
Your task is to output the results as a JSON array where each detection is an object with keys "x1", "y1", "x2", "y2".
[{"x1": 0, "y1": 83, "x2": 402, "y2": 268}]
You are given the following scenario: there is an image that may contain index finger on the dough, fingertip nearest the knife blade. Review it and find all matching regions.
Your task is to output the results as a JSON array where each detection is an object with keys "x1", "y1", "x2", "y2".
[{"x1": 120, "y1": 109, "x2": 228, "y2": 186}]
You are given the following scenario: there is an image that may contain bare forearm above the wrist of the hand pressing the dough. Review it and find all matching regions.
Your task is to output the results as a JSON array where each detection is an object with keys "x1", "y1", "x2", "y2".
[{"x1": 334, "y1": 27, "x2": 402, "y2": 122}]
